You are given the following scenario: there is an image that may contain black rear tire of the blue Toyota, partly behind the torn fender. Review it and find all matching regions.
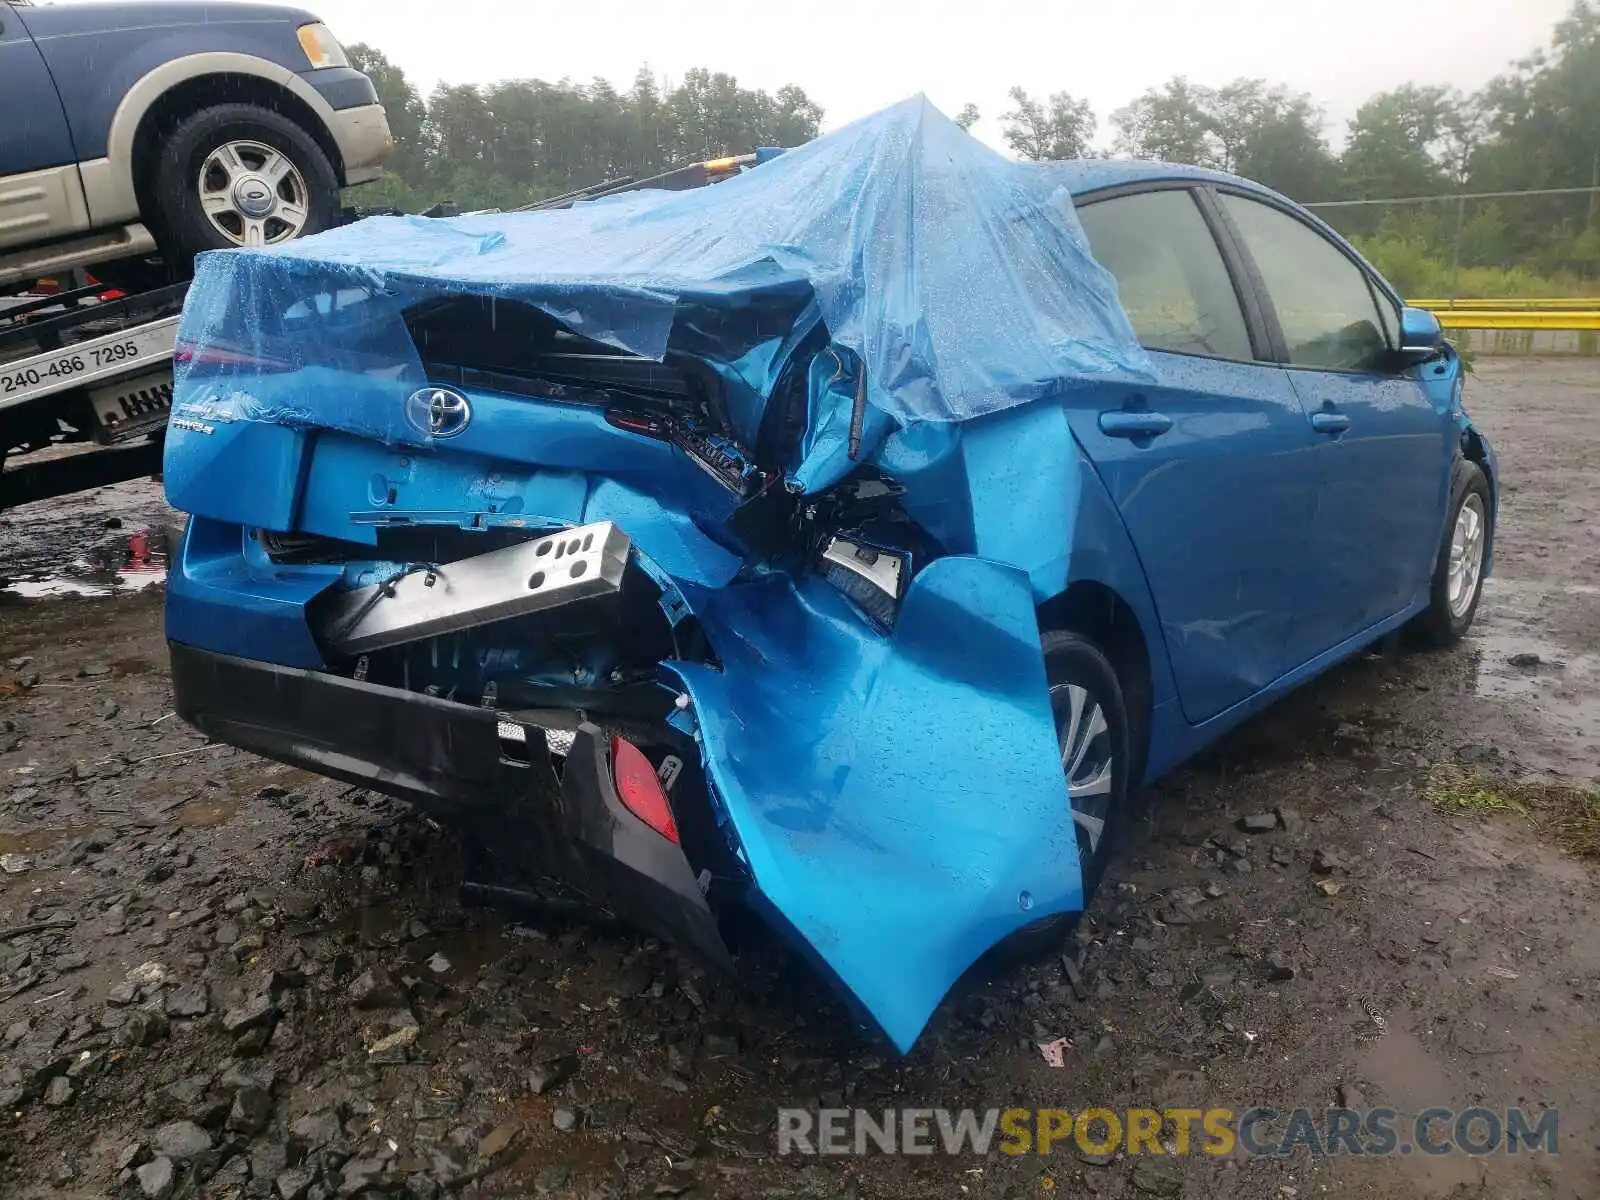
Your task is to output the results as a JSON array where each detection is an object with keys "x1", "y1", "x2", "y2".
[{"x1": 998, "y1": 630, "x2": 1134, "y2": 958}]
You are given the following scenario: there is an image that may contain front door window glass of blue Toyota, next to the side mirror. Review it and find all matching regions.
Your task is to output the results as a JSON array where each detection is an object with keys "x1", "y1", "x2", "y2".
[{"x1": 1222, "y1": 192, "x2": 1394, "y2": 371}]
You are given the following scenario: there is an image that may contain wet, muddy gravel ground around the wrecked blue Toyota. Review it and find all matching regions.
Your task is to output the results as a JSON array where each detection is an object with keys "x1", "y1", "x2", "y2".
[{"x1": 0, "y1": 360, "x2": 1600, "y2": 1200}]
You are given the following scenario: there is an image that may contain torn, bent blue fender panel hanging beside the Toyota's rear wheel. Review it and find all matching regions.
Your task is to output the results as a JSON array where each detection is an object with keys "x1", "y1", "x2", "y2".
[{"x1": 669, "y1": 557, "x2": 1083, "y2": 1050}]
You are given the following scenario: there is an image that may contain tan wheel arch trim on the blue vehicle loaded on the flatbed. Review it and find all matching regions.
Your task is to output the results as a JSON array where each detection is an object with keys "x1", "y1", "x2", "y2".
[{"x1": 83, "y1": 51, "x2": 344, "y2": 232}]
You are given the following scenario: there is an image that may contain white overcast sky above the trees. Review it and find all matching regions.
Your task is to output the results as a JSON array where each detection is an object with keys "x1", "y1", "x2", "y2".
[{"x1": 68, "y1": 0, "x2": 1570, "y2": 146}]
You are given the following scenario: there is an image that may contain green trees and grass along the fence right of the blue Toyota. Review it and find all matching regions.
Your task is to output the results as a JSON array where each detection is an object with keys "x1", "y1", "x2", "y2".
[{"x1": 1112, "y1": 0, "x2": 1600, "y2": 298}]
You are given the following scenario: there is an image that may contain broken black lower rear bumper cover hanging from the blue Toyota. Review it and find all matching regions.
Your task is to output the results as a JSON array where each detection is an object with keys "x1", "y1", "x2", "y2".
[{"x1": 170, "y1": 642, "x2": 728, "y2": 965}]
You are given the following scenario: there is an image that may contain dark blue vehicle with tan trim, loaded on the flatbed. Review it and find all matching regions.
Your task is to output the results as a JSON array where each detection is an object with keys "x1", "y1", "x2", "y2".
[{"x1": 0, "y1": 0, "x2": 394, "y2": 290}]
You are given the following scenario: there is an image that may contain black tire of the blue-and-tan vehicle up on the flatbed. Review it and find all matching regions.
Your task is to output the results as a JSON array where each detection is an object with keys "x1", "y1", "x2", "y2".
[{"x1": 150, "y1": 104, "x2": 341, "y2": 277}]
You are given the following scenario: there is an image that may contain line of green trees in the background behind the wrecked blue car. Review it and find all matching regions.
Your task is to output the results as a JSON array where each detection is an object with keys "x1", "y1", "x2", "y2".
[{"x1": 350, "y1": 0, "x2": 1600, "y2": 296}]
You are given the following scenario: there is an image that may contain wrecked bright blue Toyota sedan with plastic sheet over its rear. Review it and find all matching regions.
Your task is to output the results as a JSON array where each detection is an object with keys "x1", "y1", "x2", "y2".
[{"x1": 156, "y1": 98, "x2": 1499, "y2": 1048}]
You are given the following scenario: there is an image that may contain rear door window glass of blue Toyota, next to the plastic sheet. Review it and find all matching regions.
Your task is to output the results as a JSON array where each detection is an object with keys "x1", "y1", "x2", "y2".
[{"x1": 1078, "y1": 189, "x2": 1254, "y2": 362}]
